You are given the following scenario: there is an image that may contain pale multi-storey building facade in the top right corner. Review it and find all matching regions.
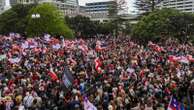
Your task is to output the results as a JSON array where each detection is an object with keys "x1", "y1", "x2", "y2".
[{"x1": 157, "y1": 0, "x2": 194, "y2": 13}]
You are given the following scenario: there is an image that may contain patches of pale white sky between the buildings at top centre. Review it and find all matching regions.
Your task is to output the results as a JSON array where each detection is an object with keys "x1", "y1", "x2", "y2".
[{"x1": 79, "y1": 0, "x2": 135, "y2": 13}]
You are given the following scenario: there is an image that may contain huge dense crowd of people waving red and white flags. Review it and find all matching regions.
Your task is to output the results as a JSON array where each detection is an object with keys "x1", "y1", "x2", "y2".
[{"x1": 0, "y1": 34, "x2": 194, "y2": 110}]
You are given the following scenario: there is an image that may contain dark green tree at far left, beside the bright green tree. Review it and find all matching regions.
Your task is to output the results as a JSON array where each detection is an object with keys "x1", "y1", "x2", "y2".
[{"x1": 0, "y1": 4, "x2": 34, "y2": 34}]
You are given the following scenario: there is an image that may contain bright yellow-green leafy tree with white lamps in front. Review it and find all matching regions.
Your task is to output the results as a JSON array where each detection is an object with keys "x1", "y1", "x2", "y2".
[{"x1": 26, "y1": 3, "x2": 73, "y2": 38}]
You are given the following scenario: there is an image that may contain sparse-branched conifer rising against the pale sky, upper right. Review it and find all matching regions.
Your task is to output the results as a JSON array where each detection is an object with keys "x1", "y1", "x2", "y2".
[{"x1": 135, "y1": 0, "x2": 162, "y2": 14}]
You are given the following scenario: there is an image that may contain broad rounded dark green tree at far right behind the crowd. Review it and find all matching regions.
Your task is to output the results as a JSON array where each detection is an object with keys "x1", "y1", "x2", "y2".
[{"x1": 132, "y1": 9, "x2": 194, "y2": 41}]
